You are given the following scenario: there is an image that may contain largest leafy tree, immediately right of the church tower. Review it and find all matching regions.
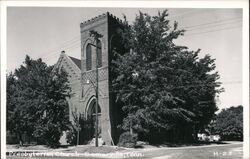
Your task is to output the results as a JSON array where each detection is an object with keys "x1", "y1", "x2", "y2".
[{"x1": 111, "y1": 10, "x2": 223, "y2": 141}]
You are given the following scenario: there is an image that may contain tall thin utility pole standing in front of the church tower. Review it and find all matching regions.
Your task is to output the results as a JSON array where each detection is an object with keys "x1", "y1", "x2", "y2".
[{"x1": 89, "y1": 30, "x2": 103, "y2": 147}]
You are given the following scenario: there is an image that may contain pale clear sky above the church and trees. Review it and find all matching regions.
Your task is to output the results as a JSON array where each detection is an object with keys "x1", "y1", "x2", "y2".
[{"x1": 7, "y1": 7, "x2": 243, "y2": 109}]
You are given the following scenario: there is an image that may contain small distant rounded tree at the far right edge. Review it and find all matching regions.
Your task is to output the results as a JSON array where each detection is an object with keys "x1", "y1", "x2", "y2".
[{"x1": 211, "y1": 105, "x2": 243, "y2": 141}]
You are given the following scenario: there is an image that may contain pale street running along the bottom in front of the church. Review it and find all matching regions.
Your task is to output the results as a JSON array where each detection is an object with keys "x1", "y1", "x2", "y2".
[{"x1": 7, "y1": 143, "x2": 243, "y2": 159}]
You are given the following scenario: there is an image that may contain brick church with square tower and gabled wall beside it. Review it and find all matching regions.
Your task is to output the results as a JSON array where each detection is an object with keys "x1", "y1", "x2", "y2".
[{"x1": 55, "y1": 12, "x2": 123, "y2": 145}]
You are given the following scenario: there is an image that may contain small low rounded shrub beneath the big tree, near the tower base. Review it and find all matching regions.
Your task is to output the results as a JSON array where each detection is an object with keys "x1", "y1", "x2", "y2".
[{"x1": 118, "y1": 132, "x2": 138, "y2": 148}]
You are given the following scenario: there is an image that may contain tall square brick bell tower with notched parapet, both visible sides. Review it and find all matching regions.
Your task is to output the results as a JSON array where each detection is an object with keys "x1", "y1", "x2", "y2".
[{"x1": 80, "y1": 12, "x2": 125, "y2": 145}]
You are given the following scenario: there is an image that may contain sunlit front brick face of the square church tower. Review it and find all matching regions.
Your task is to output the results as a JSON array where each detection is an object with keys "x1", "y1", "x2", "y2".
[{"x1": 80, "y1": 14, "x2": 112, "y2": 145}]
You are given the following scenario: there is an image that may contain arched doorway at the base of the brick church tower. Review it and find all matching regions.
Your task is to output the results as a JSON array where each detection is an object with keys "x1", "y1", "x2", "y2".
[{"x1": 86, "y1": 98, "x2": 102, "y2": 138}]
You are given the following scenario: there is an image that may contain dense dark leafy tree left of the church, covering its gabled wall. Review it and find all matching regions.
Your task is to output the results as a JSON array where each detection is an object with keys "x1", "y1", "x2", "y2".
[{"x1": 7, "y1": 56, "x2": 70, "y2": 146}]
